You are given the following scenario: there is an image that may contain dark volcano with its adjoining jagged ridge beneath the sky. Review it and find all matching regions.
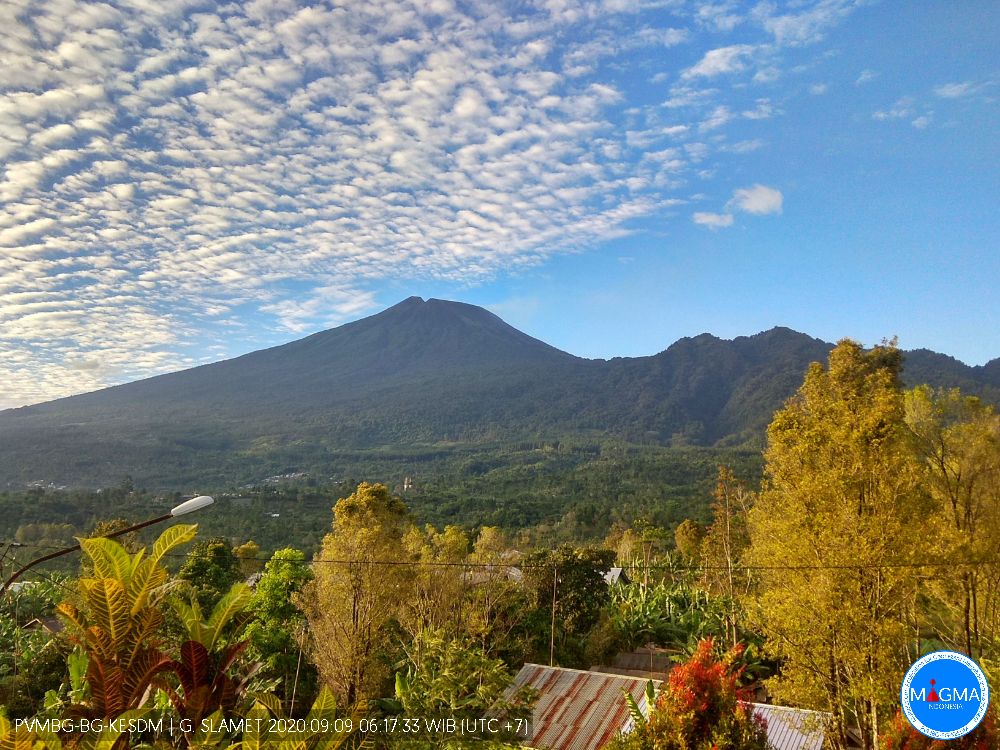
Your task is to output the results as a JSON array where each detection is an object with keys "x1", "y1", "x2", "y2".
[{"x1": 0, "y1": 297, "x2": 1000, "y2": 487}]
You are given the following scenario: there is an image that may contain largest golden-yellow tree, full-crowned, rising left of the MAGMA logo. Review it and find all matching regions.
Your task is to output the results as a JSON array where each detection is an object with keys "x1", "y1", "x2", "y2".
[{"x1": 748, "y1": 340, "x2": 927, "y2": 750}]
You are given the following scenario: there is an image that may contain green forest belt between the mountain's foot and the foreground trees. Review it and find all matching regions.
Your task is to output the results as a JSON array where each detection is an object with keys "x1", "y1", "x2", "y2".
[{"x1": 0, "y1": 441, "x2": 761, "y2": 569}]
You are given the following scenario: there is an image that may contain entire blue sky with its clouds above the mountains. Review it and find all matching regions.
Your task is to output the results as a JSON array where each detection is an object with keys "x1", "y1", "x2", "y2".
[{"x1": 0, "y1": 0, "x2": 1000, "y2": 407}]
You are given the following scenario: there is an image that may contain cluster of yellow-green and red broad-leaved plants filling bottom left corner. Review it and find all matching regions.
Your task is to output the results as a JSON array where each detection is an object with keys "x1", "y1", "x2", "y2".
[{"x1": 0, "y1": 525, "x2": 372, "y2": 750}]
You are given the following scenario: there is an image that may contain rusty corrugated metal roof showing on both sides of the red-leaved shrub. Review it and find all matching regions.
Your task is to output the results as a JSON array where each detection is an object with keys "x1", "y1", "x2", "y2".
[{"x1": 514, "y1": 664, "x2": 829, "y2": 750}]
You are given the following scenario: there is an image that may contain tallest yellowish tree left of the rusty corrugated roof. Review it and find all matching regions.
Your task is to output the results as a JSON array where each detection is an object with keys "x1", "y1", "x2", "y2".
[{"x1": 299, "y1": 483, "x2": 412, "y2": 704}]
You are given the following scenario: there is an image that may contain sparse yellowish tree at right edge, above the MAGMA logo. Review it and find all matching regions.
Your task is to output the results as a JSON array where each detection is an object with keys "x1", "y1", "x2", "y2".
[{"x1": 906, "y1": 386, "x2": 1000, "y2": 659}]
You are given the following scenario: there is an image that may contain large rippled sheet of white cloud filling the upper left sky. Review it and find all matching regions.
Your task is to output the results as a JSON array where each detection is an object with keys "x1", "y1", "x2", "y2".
[{"x1": 0, "y1": 0, "x2": 864, "y2": 408}]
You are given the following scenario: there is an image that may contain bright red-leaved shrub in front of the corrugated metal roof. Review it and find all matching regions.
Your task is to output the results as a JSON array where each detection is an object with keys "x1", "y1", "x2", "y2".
[{"x1": 608, "y1": 639, "x2": 767, "y2": 750}]
